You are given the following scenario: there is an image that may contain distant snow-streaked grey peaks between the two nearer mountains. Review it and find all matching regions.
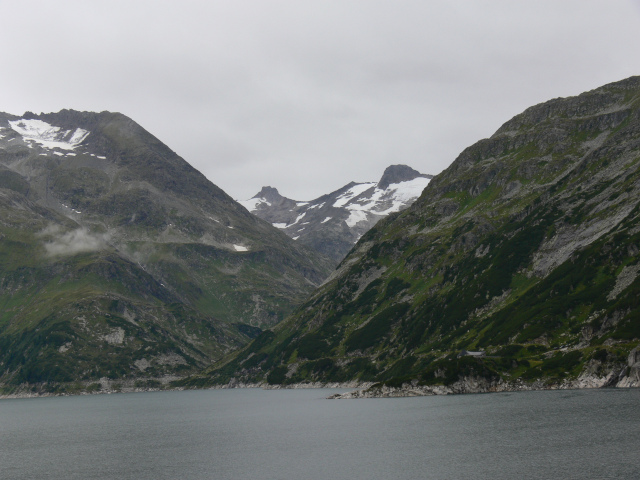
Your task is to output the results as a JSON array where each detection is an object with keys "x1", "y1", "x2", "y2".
[{"x1": 240, "y1": 165, "x2": 433, "y2": 265}]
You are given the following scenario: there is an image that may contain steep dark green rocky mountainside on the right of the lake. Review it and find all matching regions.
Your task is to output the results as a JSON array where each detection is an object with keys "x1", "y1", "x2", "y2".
[{"x1": 192, "y1": 77, "x2": 640, "y2": 395}]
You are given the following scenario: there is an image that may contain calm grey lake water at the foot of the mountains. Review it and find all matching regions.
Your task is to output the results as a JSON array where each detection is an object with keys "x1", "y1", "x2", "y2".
[{"x1": 0, "y1": 389, "x2": 640, "y2": 480}]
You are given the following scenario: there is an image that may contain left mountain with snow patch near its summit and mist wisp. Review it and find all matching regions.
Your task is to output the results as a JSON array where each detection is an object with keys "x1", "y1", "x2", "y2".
[{"x1": 0, "y1": 110, "x2": 330, "y2": 390}]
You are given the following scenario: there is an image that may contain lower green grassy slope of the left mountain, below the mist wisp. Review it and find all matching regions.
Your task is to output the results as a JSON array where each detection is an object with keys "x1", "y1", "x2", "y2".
[{"x1": 0, "y1": 190, "x2": 250, "y2": 391}]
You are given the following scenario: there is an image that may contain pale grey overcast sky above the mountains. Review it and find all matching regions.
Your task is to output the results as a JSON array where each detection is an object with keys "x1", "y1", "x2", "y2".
[{"x1": 0, "y1": 0, "x2": 640, "y2": 200}]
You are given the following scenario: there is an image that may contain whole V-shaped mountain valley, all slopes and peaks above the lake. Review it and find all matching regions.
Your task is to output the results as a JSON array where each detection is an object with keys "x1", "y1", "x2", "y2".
[{"x1": 0, "y1": 77, "x2": 640, "y2": 397}]
